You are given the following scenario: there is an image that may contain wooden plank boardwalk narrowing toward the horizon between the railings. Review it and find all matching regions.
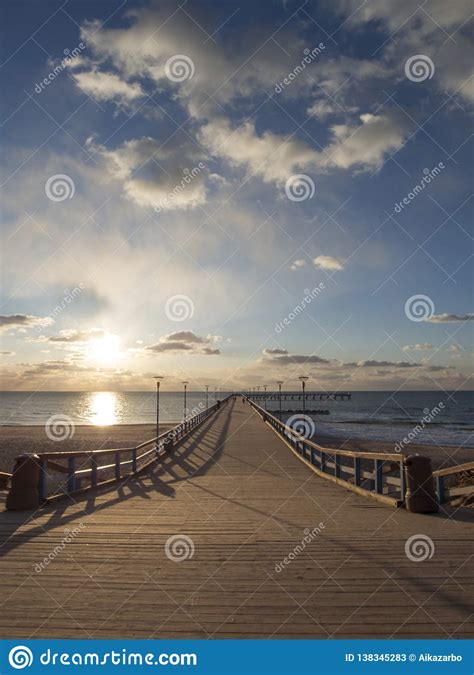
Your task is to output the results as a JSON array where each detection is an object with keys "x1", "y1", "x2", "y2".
[{"x1": 0, "y1": 400, "x2": 474, "y2": 638}]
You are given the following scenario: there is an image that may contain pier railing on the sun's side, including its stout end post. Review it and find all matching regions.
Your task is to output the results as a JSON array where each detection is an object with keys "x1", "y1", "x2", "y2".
[{"x1": 6, "y1": 396, "x2": 232, "y2": 510}]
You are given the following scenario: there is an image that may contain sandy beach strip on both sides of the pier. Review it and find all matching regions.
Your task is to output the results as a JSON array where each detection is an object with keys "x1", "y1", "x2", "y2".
[{"x1": 0, "y1": 424, "x2": 468, "y2": 472}]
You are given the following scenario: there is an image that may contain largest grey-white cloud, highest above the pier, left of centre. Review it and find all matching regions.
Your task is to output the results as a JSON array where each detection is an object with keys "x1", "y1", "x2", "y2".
[{"x1": 76, "y1": 2, "x2": 304, "y2": 118}]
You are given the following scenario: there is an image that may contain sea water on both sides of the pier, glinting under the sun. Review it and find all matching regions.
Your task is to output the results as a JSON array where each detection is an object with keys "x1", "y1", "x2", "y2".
[{"x1": 0, "y1": 391, "x2": 474, "y2": 447}]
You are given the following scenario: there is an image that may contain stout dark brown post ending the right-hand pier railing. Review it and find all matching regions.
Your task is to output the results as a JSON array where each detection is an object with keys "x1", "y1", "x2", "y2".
[{"x1": 403, "y1": 455, "x2": 439, "y2": 513}]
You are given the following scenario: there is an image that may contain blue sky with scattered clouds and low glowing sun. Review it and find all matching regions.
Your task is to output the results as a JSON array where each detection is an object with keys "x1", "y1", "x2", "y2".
[{"x1": 0, "y1": 0, "x2": 474, "y2": 390}]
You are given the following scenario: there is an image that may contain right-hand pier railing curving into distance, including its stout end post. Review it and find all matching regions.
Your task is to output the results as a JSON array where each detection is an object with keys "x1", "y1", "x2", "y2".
[{"x1": 245, "y1": 397, "x2": 446, "y2": 513}]
